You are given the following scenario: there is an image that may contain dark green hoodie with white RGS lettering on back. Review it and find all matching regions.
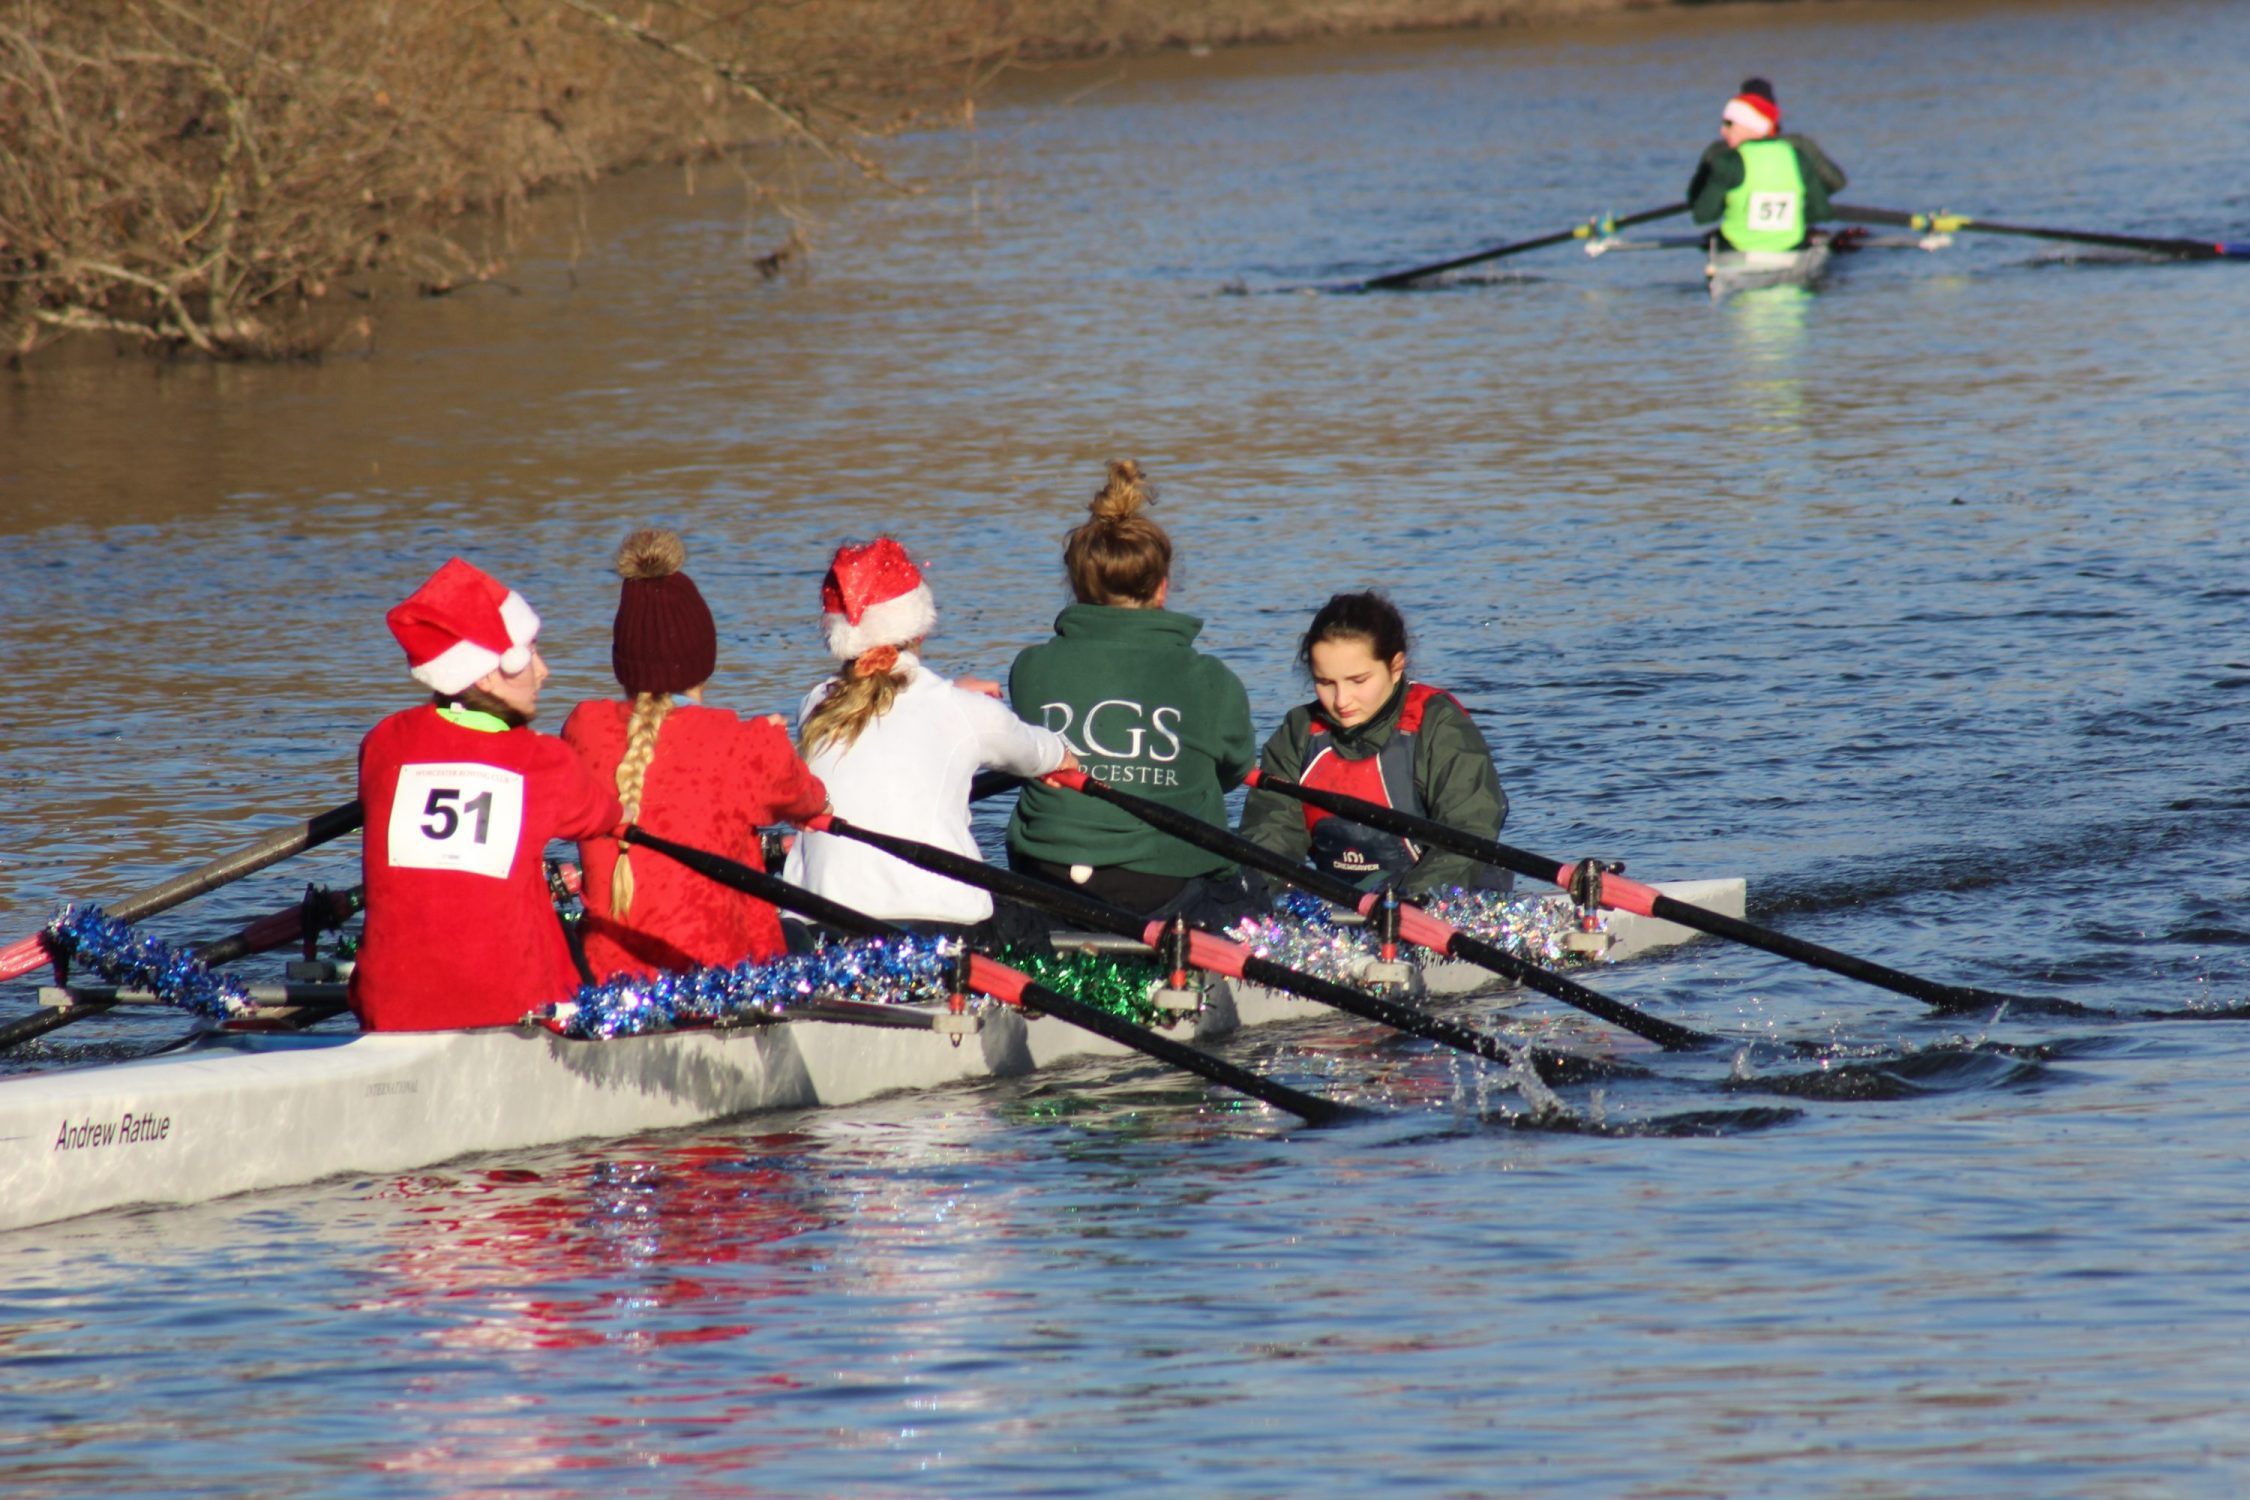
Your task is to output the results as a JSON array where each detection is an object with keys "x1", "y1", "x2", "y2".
[{"x1": 1008, "y1": 605, "x2": 1258, "y2": 875}]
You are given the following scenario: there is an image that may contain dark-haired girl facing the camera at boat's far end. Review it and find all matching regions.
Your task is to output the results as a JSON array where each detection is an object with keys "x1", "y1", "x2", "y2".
[{"x1": 1242, "y1": 594, "x2": 1510, "y2": 895}]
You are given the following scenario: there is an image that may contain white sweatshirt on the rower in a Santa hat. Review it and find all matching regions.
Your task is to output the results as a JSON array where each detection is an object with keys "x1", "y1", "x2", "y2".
[{"x1": 783, "y1": 652, "x2": 1069, "y2": 924}]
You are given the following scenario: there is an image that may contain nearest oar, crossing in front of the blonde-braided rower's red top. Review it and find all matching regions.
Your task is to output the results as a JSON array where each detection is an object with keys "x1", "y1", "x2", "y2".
[{"x1": 619, "y1": 828, "x2": 1364, "y2": 1124}]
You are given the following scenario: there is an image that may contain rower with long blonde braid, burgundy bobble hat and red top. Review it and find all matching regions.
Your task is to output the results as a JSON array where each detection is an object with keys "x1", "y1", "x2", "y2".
[{"x1": 567, "y1": 531, "x2": 828, "y2": 999}]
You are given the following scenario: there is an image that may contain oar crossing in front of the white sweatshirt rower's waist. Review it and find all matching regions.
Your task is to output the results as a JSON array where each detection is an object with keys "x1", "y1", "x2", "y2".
[{"x1": 806, "y1": 814, "x2": 1613, "y2": 1084}]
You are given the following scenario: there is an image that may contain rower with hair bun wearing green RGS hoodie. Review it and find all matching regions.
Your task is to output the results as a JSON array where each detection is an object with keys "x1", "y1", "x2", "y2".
[{"x1": 1008, "y1": 459, "x2": 1262, "y2": 927}]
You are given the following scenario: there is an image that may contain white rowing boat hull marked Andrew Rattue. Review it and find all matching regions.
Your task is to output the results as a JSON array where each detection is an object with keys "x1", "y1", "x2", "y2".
[{"x1": 0, "y1": 879, "x2": 1744, "y2": 1230}]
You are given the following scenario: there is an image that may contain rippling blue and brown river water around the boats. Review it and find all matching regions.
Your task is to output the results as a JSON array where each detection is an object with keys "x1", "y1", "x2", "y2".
[{"x1": 0, "y1": 2, "x2": 2250, "y2": 1496}]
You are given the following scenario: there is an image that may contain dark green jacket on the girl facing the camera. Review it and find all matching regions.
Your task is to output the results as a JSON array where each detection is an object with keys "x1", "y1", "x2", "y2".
[{"x1": 1242, "y1": 681, "x2": 1508, "y2": 893}]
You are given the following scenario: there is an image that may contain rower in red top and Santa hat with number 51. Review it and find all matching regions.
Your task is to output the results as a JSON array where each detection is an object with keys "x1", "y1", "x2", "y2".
[{"x1": 351, "y1": 558, "x2": 619, "y2": 1032}]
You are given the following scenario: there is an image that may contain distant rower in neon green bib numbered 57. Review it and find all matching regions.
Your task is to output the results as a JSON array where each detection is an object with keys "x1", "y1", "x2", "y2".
[{"x1": 1688, "y1": 79, "x2": 1845, "y2": 252}]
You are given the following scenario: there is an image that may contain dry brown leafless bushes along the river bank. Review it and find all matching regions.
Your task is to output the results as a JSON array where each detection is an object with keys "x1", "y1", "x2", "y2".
[{"x1": 0, "y1": 0, "x2": 1634, "y2": 360}]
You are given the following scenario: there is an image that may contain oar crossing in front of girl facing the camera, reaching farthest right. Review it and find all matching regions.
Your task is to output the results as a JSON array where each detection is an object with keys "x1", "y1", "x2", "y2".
[{"x1": 1249, "y1": 771, "x2": 2068, "y2": 1010}]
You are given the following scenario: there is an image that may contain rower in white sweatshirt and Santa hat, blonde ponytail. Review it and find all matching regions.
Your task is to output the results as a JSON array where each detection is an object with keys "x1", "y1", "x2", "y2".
[{"x1": 785, "y1": 537, "x2": 1078, "y2": 942}]
